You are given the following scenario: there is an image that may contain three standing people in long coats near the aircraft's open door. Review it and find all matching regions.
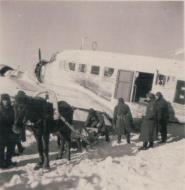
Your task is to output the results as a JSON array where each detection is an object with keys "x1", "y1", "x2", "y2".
[{"x1": 113, "y1": 92, "x2": 169, "y2": 150}]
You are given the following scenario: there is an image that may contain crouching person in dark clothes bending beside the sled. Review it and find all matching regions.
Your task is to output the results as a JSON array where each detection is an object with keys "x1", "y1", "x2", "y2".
[{"x1": 85, "y1": 109, "x2": 110, "y2": 141}]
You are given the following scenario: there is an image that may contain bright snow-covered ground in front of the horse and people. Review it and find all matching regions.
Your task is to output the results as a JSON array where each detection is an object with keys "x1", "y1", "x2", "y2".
[{"x1": 0, "y1": 132, "x2": 185, "y2": 190}]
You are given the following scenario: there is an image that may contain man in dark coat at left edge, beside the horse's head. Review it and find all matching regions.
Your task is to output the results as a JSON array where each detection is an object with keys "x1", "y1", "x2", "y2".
[{"x1": 0, "y1": 94, "x2": 15, "y2": 168}]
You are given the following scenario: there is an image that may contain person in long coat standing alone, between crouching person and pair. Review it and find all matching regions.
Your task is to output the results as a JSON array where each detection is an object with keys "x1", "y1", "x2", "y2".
[{"x1": 113, "y1": 98, "x2": 132, "y2": 144}]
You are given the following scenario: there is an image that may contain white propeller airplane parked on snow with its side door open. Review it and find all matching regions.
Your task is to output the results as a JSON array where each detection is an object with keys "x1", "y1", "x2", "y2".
[{"x1": 0, "y1": 50, "x2": 185, "y2": 122}]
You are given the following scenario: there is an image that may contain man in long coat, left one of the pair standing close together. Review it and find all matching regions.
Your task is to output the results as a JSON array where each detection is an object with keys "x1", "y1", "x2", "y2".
[{"x1": 139, "y1": 93, "x2": 156, "y2": 150}]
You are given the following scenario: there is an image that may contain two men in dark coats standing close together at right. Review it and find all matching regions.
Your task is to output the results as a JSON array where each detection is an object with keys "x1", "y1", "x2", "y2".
[{"x1": 140, "y1": 92, "x2": 169, "y2": 150}]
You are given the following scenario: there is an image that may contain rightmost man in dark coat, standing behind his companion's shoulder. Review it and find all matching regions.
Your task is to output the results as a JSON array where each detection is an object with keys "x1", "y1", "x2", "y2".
[{"x1": 155, "y1": 92, "x2": 169, "y2": 143}]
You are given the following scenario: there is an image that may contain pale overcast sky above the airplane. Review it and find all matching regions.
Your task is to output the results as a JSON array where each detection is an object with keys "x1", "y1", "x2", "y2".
[{"x1": 0, "y1": 1, "x2": 184, "y2": 69}]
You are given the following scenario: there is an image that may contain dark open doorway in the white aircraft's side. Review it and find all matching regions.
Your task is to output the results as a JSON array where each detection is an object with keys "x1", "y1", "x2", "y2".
[{"x1": 132, "y1": 72, "x2": 154, "y2": 102}]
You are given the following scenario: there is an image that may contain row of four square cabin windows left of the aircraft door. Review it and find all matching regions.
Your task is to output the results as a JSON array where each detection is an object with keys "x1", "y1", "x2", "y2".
[{"x1": 68, "y1": 62, "x2": 114, "y2": 77}]
